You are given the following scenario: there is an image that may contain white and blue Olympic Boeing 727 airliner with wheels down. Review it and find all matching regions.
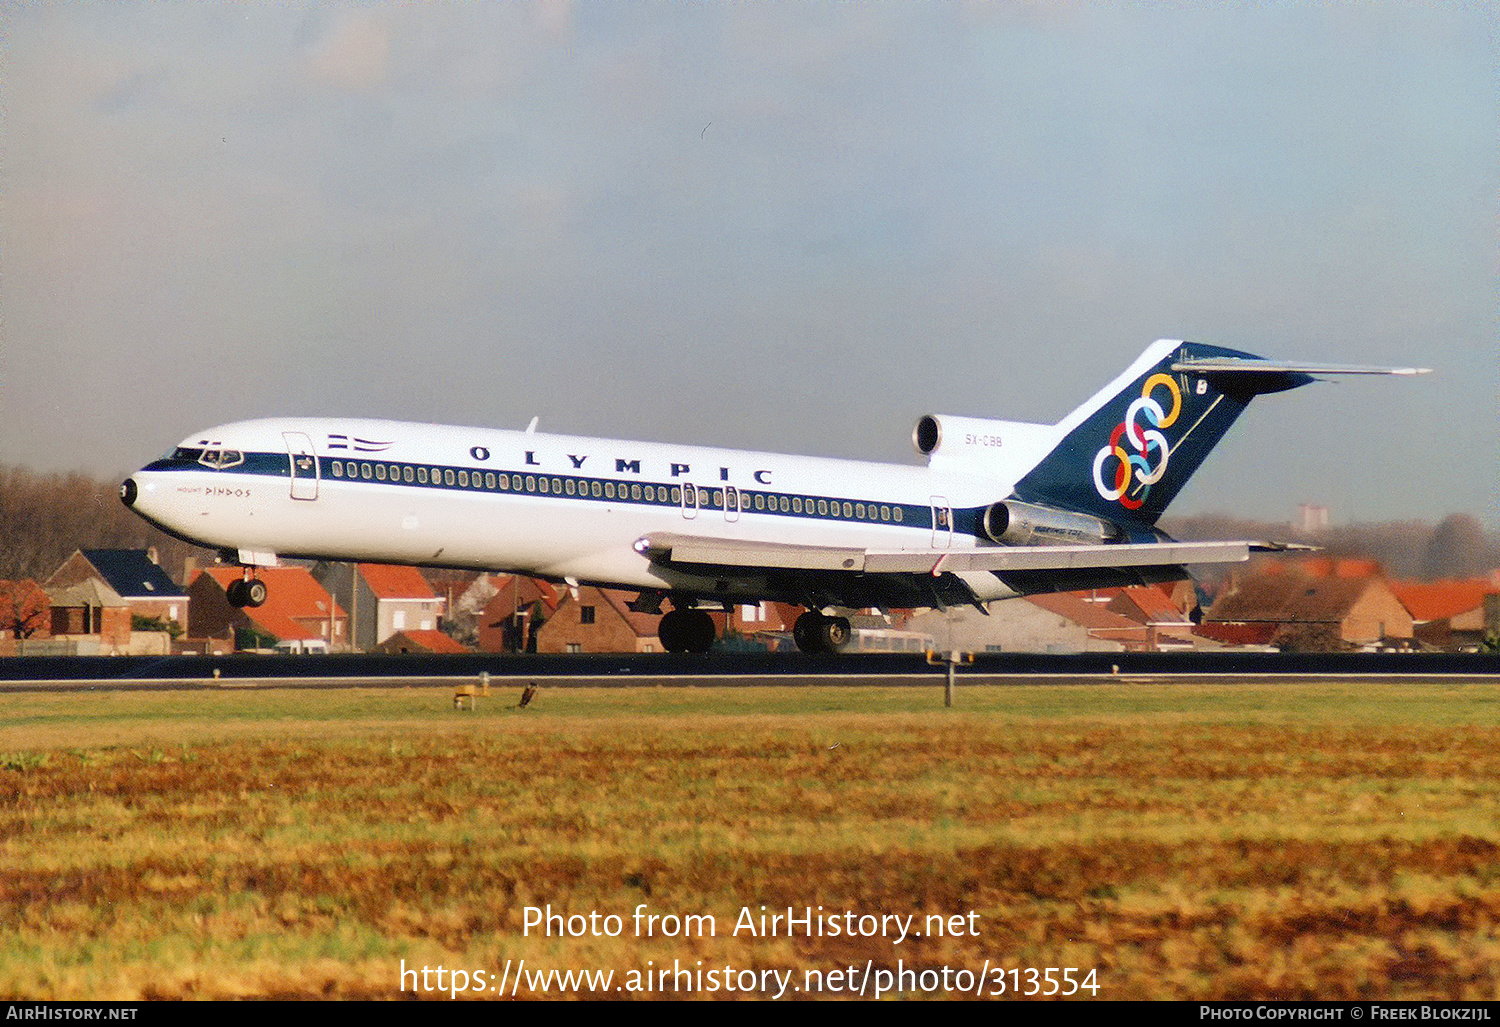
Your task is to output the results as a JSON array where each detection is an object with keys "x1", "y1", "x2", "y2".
[{"x1": 120, "y1": 340, "x2": 1425, "y2": 651}]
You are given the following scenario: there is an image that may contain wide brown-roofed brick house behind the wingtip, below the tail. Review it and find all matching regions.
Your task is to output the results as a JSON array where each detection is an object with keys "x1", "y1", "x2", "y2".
[{"x1": 1196, "y1": 570, "x2": 1413, "y2": 651}]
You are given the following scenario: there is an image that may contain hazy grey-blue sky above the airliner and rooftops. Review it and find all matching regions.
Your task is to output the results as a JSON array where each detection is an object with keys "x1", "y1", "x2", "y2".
[{"x1": 0, "y1": 3, "x2": 1500, "y2": 528}]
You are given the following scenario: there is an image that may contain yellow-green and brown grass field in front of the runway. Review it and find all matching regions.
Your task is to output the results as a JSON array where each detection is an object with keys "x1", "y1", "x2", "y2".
[{"x1": 0, "y1": 684, "x2": 1500, "y2": 1000}]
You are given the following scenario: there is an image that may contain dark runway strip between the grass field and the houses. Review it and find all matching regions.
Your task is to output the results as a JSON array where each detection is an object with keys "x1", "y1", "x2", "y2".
[{"x1": 0, "y1": 652, "x2": 1500, "y2": 693}]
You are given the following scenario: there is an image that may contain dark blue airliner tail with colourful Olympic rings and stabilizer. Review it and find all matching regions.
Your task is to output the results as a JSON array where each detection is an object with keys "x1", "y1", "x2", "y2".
[{"x1": 1016, "y1": 340, "x2": 1314, "y2": 525}]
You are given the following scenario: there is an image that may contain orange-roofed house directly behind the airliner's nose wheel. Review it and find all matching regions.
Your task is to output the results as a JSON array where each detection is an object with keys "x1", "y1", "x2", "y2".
[{"x1": 188, "y1": 567, "x2": 350, "y2": 651}]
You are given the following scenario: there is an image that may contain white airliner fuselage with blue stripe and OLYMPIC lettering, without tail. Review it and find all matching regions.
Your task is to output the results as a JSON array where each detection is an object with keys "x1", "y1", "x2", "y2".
[{"x1": 132, "y1": 418, "x2": 1034, "y2": 600}]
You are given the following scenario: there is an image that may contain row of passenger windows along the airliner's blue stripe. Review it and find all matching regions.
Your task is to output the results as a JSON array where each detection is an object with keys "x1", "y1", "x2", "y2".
[{"x1": 329, "y1": 460, "x2": 903, "y2": 523}]
